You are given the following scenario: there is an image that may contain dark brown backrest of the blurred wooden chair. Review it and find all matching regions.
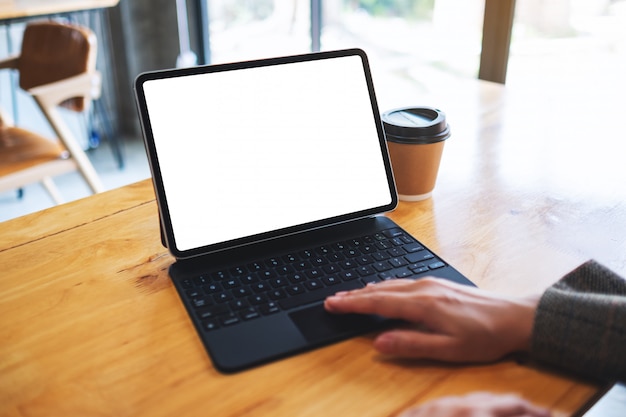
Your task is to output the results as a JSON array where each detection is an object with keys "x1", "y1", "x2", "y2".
[{"x1": 17, "y1": 21, "x2": 97, "y2": 111}]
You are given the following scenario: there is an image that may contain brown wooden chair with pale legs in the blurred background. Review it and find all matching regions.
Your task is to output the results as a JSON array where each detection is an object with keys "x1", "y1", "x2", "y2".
[{"x1": 0, "y1": 21, "x2": 104, "y2": 204}]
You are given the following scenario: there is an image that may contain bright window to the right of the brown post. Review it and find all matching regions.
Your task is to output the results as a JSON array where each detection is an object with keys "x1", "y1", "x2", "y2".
[{"x1": 507, "y1": 0, "x2": 626, "y2": 90}]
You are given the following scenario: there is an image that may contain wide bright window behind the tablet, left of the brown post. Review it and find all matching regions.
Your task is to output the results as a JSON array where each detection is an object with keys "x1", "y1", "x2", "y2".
[{"x1": 205, "y1": 0, "x2": 484, "y2": 85}]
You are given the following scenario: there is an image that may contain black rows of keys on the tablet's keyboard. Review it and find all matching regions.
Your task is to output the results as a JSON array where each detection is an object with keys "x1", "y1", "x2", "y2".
[{"x1": 181, "y1": 228, "x2": 446, "y2": 331}]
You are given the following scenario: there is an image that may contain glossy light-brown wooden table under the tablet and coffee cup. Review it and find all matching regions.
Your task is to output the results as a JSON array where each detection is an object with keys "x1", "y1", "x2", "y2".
[{"x1": 0, "y1": 77, "x2": 626, "y2": 417}]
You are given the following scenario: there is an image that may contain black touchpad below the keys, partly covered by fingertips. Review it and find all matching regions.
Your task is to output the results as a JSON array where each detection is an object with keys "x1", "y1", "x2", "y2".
[{"x1": 289, "y1": 304, "x2": 383, "y2": 343}]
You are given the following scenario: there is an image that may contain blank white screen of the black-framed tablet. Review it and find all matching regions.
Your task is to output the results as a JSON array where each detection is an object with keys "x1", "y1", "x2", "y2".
[{"x1": 144, "y1": 56, "x2": 392, "y2": 251}]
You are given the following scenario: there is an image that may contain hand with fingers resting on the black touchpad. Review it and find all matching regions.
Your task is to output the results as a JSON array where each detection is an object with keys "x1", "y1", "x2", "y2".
[{"x1": 324, "y1": 278, "x2": 539, "y2": 362}]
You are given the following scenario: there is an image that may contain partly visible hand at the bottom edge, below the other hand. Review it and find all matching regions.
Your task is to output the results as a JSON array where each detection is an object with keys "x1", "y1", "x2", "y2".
[{"x1": 399, "y1": 392, "x2": 550, "y2": 417}]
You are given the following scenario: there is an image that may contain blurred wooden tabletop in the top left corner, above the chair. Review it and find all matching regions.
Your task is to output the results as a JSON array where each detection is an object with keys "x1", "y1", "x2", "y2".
[{"x1": 0, "y1": 0, "x2": 119, "y2": 20}]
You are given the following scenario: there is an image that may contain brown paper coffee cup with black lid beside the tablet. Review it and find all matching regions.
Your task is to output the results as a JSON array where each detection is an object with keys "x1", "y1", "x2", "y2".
[{"x1": 382, "y1": 107, "x2": 450, "y2": 201}]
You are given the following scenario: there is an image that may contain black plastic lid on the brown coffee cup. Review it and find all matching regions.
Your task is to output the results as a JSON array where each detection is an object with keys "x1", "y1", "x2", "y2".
[{"x1": 382, "y1": 107, "x2": 450, "y2": 144}]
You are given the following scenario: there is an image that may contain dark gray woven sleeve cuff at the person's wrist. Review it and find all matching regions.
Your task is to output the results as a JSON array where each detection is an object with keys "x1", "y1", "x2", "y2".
[{"x1": 530, "y1": 261, "x2": 626, "y2": 381}]
